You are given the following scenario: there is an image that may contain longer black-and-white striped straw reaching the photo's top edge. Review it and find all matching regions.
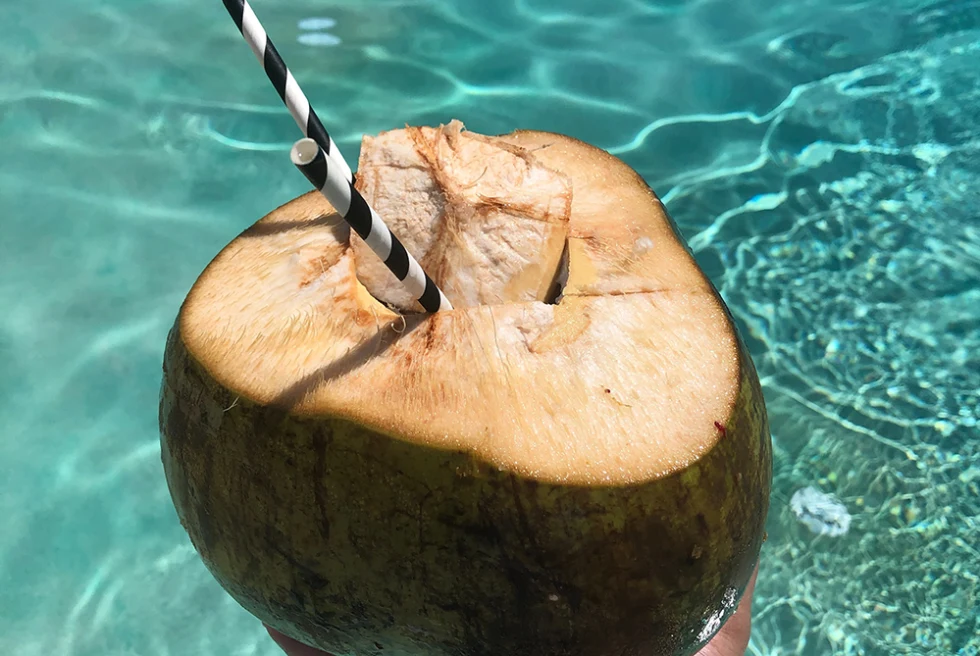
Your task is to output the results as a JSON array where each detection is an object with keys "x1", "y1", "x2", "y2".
[{"x1": 223, "y1": 0, "x2": 354, "y2": 180}]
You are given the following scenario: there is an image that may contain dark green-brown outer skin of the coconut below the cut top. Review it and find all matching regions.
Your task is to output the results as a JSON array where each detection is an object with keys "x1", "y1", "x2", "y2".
[{"x1": 160, "y1": 318, "x2": 772, "y2": 656}]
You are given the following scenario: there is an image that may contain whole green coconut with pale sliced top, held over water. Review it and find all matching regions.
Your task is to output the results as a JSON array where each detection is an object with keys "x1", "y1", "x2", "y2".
[{"x1": 160, "y1": 122, "x2": 771, "y2": 656}]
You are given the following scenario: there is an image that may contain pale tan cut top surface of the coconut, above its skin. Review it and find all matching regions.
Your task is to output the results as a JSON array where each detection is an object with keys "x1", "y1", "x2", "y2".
[{"x1": 180, "y1": 123, "x2": 742, "y2": 484}]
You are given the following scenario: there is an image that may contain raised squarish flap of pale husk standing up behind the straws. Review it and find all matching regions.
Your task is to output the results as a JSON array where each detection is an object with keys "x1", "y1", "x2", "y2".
[{"x1": 351, "y1": 121, "x2": 572, "y2": 310}]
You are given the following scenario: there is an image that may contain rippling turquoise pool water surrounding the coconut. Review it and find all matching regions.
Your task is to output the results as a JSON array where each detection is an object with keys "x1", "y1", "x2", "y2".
[{"x1": 0, "y1": 0, "x2": 980, "y2": 656}]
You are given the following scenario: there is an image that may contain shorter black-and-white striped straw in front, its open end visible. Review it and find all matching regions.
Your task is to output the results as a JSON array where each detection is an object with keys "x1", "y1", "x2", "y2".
[{"x1": 290, "y1": 138, "x2": 453, "y2": 312}]
